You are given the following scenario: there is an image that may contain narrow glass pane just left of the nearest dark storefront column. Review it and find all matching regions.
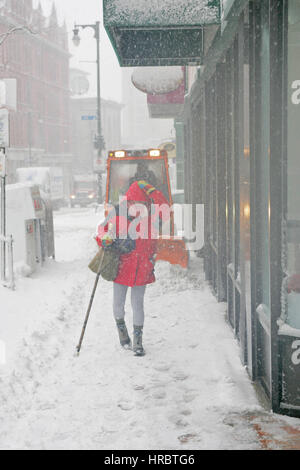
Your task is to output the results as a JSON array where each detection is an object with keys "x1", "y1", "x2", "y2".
[{"x1": 252, "y1": 0, "x2": 272, "y2": 395}]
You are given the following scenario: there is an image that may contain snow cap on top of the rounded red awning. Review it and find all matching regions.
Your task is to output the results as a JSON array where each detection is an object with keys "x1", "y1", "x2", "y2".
[{"x1": 131, "y1": 67, "x2": 184, "y2": 95}]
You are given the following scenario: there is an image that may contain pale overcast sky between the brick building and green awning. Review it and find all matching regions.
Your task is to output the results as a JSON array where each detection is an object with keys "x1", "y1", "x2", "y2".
[{"x1": 34, "y1": 0, "x2": 122, "y2": 102}]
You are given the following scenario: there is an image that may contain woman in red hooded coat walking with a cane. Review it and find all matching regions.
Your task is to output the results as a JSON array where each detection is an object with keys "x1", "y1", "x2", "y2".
[{"x1": 96, "y1": 180, "x2": 169, "y2": 356}]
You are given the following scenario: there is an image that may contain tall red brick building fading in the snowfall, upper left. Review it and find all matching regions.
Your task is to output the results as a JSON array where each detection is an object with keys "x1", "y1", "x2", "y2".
[{"x1": 0, "y1": 0, "x2": 71, "y2": 193}]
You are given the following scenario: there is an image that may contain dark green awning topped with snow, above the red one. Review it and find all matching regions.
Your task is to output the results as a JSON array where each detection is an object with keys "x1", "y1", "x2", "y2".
[{"x1": 103, "y1": 0, "x2": 221, "y2": 67}]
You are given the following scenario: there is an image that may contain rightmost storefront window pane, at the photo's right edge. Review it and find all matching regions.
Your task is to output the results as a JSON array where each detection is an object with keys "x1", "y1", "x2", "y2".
[{"x1": 286, "y1": 0, "x2": 300, "y2": 329}]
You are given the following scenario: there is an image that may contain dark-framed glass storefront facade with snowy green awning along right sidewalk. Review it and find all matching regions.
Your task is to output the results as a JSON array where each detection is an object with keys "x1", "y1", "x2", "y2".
[{"x1": 104, "y1": 0, "x2": 300, "y2": 417}]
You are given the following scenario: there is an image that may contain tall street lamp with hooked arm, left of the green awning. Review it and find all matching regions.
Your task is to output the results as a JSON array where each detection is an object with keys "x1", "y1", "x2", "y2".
[{"x1": 73, "y1": 21, "x2": 105, "y2": 204}]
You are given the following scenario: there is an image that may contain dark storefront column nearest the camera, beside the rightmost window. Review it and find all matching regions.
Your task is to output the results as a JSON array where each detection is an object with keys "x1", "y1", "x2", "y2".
[{"x1": 270, "y1": 0, "x2": 284, "y2": 411}]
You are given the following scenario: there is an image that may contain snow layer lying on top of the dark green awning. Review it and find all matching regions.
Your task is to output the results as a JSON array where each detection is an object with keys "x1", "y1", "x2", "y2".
[{"x1": 104, "y1": 0, "x2": 219, "y2": 27}]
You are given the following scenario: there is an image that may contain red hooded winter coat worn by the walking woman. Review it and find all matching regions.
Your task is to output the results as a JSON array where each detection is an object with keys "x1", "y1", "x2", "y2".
[{"x1": 96, "y1": 182, "x2": 169, "y2": 287}]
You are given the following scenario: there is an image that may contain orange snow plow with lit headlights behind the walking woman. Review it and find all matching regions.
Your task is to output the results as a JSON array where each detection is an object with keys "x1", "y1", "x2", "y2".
[{"x1": 105, "y1": 149, "x2": 189, "y2": 268}]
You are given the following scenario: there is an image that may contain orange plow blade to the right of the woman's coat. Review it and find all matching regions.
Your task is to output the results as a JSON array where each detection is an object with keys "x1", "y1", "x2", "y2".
[{"x1": 156, "y1": 238, "x2": 189, "y2": 269}]
